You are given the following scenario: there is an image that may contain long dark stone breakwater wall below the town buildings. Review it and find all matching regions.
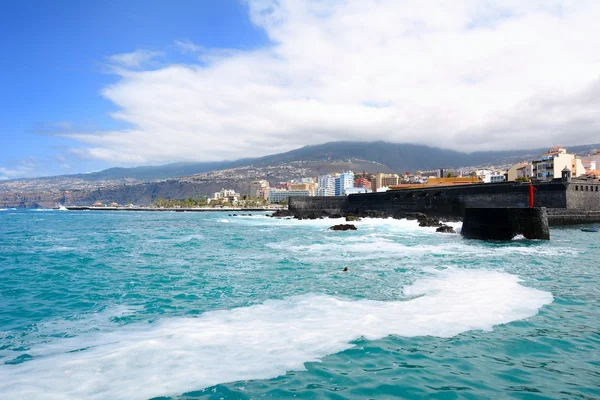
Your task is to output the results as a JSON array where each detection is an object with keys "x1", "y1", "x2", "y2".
[{"x1": 288, "y1": 179, "x2": 600, "y2": 225}]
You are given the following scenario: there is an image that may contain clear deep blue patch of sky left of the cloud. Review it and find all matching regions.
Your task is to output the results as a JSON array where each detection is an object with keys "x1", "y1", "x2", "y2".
[{"x1": 0, "y1": 0, "x2": 266, "y2": 177}]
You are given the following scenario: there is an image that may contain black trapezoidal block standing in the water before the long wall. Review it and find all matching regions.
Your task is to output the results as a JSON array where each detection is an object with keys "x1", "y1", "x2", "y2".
[{"x1": 461, "y1": 207, "x2": 550, "y2": 240}]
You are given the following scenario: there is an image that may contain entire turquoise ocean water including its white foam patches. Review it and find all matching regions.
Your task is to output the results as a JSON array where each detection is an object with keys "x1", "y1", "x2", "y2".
[{"x1": 0, "y1": 209, "x2": 600, "y2": 399}]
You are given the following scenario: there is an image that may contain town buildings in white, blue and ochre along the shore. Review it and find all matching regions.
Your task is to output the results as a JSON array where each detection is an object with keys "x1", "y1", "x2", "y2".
[{"x1": 92, "y1": 146, "x2": 600, "y2": 208}]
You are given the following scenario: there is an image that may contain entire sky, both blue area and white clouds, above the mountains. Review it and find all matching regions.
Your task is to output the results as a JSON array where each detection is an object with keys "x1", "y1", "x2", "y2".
[{"x1": 0, "y1": 0, "x2": 600, "y2": 180}]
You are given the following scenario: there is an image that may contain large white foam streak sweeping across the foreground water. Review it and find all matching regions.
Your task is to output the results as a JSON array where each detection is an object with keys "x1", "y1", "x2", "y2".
[{"x1": 0, "y1": 269, "x2": 552, "y2": 399}]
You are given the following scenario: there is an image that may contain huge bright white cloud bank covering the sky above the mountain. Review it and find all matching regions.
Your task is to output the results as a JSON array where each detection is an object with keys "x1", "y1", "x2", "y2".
[{"x1": 67, "y1": 0, "x2": 600, "y2": 164}]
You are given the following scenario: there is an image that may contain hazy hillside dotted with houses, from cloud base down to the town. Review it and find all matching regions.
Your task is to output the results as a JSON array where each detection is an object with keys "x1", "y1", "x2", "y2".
[{"x1": 0, "y1": 141, "x2": 600, "y2": 208}]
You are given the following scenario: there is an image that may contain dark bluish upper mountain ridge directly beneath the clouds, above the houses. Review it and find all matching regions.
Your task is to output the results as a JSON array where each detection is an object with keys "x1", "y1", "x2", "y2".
[{"x1": 2, "y1": 141, "x2": 600, "y2": 183}]
